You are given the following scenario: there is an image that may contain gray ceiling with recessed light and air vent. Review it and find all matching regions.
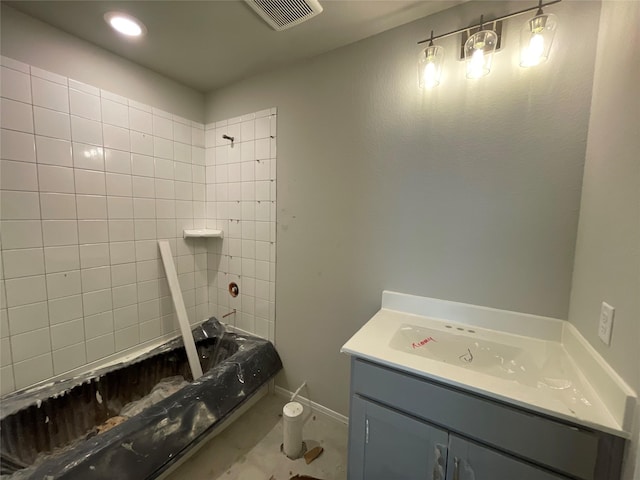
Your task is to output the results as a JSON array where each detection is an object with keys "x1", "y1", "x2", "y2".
[{"x1": 3, "y1": 0, "x2": 464, "y2": 92}]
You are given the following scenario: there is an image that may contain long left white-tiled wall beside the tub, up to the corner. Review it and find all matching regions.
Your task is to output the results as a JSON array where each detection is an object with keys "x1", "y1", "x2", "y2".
[{"x1": 0, "y1": 57, "x2": 214, "y2": 394}]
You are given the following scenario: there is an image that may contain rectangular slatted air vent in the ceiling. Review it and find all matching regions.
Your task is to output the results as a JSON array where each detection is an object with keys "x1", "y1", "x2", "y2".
[{"x1": 245, "y1": 0, "x2": 322, "y2": 30}]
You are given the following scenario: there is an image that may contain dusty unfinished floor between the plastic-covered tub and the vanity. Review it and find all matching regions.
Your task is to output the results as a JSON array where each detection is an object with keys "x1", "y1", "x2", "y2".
[{"x1": 166, "y1": 395, "x2": 347, "y2": 480}]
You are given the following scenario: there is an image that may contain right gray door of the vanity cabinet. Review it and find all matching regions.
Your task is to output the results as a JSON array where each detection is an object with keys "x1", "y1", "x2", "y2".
[{"x1": 447, "y1": 435, "x2": 567, "y2": 480}]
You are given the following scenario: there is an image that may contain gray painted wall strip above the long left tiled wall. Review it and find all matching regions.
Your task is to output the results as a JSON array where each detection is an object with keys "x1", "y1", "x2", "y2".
[{"x1": 0, "y1": 5, "x2": 204, "y2": 122}]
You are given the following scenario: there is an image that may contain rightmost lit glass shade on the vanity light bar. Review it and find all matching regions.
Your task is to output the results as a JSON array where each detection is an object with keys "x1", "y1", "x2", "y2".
[{"x1": 520, "y1": 14, "x2": 558, "y2": 67}]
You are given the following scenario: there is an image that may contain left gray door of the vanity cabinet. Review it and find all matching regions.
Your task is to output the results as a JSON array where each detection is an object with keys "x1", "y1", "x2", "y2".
[{"x1": 349, "y1": 395, "x2": 448, "y2": 480}]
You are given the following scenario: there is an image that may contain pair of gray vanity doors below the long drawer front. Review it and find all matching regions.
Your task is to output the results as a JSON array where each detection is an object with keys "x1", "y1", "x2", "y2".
[{"x1": 349, "y1": 395, "x2": 566, "y2": 480}]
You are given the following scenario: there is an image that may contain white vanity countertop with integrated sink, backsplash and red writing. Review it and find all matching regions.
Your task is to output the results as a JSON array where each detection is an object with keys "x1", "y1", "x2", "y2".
[{"x1": 341, "y1": 292, "x2": 635, "y2": 438}]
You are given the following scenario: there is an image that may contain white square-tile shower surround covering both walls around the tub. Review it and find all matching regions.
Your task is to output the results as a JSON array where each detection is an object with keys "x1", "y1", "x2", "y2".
[{"x1": 0, "y1": 57, "x2": 275, "y2": 394}]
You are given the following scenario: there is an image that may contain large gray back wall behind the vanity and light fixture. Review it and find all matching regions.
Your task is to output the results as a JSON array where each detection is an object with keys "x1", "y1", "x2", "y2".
[{"x1": 206, "y1": 2, "x2": 600, "y2": 414}]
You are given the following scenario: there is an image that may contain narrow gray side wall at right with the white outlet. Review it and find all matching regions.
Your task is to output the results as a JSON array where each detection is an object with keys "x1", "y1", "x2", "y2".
[{"x1": 569, "y1": 2, "x2": 640, "y2": 479}]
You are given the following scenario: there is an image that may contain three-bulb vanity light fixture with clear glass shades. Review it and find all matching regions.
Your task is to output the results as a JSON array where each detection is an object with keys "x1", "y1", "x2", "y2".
[{"x1": 418, "y1": 0, "x2": 562, "y2": 88}]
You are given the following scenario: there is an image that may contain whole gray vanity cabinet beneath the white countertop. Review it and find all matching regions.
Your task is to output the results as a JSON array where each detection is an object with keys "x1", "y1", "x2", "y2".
[{"x1": 348, "y1": 357, "x2": 624, "y2": 480}]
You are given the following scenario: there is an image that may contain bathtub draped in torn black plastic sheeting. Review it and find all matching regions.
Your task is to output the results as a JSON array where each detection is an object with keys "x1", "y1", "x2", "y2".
[{"x1": 0, "y1": 318, "x2": 282, "y2": 480}]
